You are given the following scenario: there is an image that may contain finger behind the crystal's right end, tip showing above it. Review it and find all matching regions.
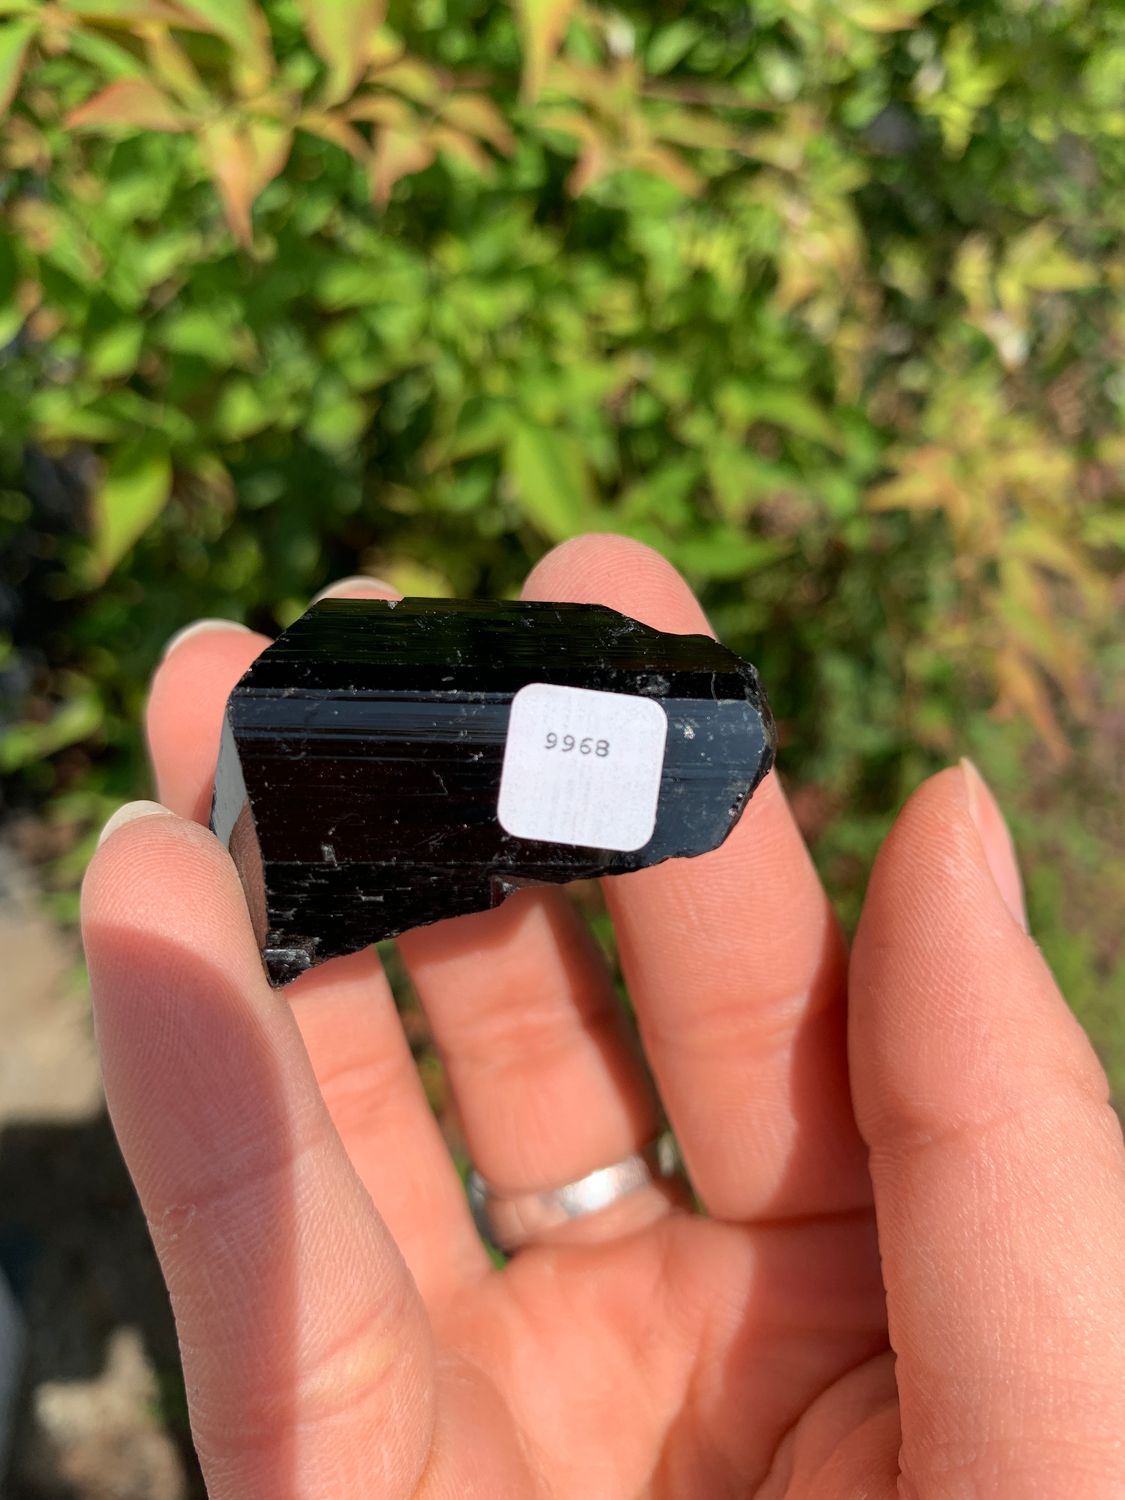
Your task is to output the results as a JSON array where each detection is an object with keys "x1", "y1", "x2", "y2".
[{"x1": 527, "y1": 537, "x2": 869, "y2": 1220}]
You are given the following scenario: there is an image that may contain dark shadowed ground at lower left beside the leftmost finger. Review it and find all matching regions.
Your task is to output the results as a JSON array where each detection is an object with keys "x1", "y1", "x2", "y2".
[{"x1": 0, "y1": 1115, "x2": 206, "y2": 1500}]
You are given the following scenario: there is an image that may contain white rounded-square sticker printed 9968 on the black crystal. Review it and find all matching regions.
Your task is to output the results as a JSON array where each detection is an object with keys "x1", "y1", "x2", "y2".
[{"x1": 497, "y1": 683, "x2": 668, "y2": 852}]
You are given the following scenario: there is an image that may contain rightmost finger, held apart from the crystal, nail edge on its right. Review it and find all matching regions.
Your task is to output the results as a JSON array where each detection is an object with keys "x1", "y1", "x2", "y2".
[{"x1": 851, "y1": 767, "x2": 1125, "y2": 1500}]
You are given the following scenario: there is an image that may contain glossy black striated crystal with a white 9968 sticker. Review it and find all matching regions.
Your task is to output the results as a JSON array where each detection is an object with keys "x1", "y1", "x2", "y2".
[{"x1": 212, "y1": 599, "x2": 776, "y2": 984}]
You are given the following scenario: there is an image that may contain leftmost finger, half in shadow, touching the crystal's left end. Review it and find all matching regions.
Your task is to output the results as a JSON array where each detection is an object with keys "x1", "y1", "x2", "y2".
[{"x1": 83, "y1": 815, "x2": 434, "y2": 1500}]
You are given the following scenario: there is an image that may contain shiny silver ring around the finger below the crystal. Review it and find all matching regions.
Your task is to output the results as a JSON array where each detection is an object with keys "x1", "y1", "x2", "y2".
[{"x1": 467, "y1": 1131, "x2": 683, "y2": 1256}]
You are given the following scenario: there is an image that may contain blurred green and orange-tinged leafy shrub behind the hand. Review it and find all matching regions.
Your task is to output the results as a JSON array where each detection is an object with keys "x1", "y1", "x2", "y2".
[{"x1": 0, "y1": 0, "x2": 1125, "y2": 1062}]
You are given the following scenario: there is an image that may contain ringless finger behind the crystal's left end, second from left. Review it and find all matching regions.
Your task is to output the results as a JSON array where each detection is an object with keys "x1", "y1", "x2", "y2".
[{"x1": 147, "y1": 591, "x2": 488, "y2": 1302}]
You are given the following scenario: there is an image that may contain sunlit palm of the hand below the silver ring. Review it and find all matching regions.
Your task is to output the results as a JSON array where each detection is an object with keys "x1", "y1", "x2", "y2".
[{"x1": 423, "y1": 1214, "x2": 896, "y2": 1500}]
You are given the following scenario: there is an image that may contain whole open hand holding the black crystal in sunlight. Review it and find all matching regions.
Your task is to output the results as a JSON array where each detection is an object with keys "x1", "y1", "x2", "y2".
[{"x1": 83, "y1": 537, "x2": 1125, "y2": 1500}]
